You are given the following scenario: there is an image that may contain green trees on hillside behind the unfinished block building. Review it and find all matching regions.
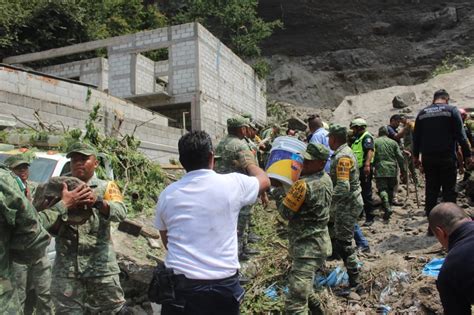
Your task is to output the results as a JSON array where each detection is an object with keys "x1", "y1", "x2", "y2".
[{"x1": 0, "y1": 0, "x2": 282, "y2": 77}]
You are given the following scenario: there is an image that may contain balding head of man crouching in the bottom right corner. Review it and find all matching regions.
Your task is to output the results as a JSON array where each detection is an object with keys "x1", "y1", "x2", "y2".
[{"x1": 428, "y1": 202, "x2": 471, "y2": 235}]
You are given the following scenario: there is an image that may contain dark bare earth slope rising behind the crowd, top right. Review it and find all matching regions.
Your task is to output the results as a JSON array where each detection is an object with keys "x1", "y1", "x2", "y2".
[{"x1": 259, "y1": 0, "x2": 474, "y2": 107}]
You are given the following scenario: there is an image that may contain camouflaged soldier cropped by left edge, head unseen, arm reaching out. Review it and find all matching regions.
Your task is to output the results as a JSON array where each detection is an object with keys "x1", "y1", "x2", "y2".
[{"x1": 0, "y1": 166, "x2": 90, "y2": 314}]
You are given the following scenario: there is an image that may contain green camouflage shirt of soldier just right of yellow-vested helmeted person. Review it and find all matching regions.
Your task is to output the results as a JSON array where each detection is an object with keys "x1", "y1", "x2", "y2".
[{"x1": 373, "y1": 136, "x2": 405, "y2": 178}]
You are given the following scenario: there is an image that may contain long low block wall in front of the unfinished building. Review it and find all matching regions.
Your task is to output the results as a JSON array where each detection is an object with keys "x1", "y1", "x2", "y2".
[{"x1": 0, "y1": 66, "x2": 182, "y2": 162}]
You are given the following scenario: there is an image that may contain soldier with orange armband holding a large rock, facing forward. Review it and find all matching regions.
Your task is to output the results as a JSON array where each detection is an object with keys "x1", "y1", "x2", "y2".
[{"x1": 52, "y1": 143, "x2": 127, "y2": 314}]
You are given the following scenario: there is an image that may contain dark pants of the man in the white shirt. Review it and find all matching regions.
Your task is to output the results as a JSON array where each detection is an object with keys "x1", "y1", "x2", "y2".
[{"x1": 161, "y1": 274, "x2": 244, "y2": 315}]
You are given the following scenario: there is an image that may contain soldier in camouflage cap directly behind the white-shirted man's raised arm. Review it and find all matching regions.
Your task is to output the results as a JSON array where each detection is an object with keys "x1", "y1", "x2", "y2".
[{"x1": 214, "y1": 116, "x2": 258, "y2": 260}]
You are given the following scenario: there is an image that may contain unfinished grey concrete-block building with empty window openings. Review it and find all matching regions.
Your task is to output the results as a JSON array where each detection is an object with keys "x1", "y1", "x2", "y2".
[{"x1": 3, "y1": 23, "x2": 266, "y2": 139}]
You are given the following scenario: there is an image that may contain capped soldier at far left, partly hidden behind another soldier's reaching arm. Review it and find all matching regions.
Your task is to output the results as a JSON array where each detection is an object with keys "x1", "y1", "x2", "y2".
[{"x1": 5, "y1": 154, "x2": 53, "y2": 315}]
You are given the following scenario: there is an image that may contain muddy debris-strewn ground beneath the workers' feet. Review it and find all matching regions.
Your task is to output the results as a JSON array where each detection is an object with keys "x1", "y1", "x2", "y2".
[{"x1": 113, "y1": 172, "x2": 469, "y2": 315}]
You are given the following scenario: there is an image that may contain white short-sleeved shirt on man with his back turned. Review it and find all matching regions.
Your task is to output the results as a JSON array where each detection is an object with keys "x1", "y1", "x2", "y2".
[{"x1": 155, "y1": 169, "x2": 259, "y2": 280}]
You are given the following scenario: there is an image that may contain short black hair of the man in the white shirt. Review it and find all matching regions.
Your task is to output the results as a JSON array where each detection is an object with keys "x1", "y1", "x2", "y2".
[{"x1": 178, "y1": 131, "x2": 213, "y2": 172}]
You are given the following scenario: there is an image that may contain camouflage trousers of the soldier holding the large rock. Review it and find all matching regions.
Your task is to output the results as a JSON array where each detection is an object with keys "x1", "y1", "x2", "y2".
[{"x1": 52, "y1": 274, "x2": 125, "y2": 315}]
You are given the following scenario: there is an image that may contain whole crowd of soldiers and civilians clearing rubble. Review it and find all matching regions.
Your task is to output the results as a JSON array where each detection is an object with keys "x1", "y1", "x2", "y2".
[{"x1": 0, "y1": 89, "x2": 474, "y2": 315}]
